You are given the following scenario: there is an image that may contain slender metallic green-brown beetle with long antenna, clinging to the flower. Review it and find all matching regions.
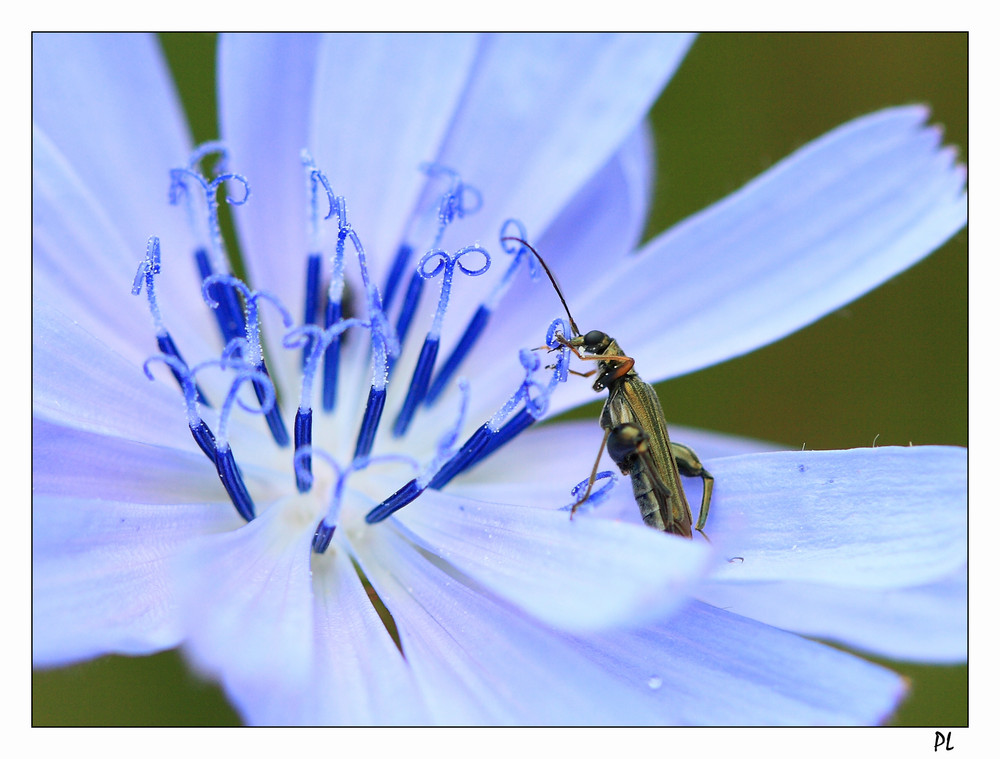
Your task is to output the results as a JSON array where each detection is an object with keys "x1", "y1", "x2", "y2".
[{"x1": 504, "y1": 238, "x2": 715, "y2": 538}]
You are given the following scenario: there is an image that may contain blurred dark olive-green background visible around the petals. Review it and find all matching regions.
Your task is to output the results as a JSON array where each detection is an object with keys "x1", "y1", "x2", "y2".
[{"x1": 32, "y1": 34, "x2": 969, "y2": 727}]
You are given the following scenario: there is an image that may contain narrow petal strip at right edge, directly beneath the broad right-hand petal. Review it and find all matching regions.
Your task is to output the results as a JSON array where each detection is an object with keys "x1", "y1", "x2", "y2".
[{"x1": 696, "y1": 565, "x2": 969, "y2": 664}]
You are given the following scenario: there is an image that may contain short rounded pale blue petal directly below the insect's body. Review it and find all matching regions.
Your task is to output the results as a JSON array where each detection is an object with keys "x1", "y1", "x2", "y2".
[{"x1": 390, "y1": 491, "x2": 711, "y2": 631}]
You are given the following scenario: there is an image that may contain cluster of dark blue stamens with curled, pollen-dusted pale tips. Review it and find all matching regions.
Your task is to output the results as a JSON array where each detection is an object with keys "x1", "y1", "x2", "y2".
[{"x1": 132, "y1": 143, "x2": 569, "y2": 553}]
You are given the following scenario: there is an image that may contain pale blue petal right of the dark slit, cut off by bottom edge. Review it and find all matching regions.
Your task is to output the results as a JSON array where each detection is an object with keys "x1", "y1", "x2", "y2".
[{"x1": 352, "y1": 525, "x2": 672, "y2": 725}]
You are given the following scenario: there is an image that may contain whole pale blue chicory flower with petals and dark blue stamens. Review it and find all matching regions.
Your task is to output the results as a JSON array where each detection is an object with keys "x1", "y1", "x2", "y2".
[{"x1": 33, "y1": 35, "x2": 966, "y2": 724}]
